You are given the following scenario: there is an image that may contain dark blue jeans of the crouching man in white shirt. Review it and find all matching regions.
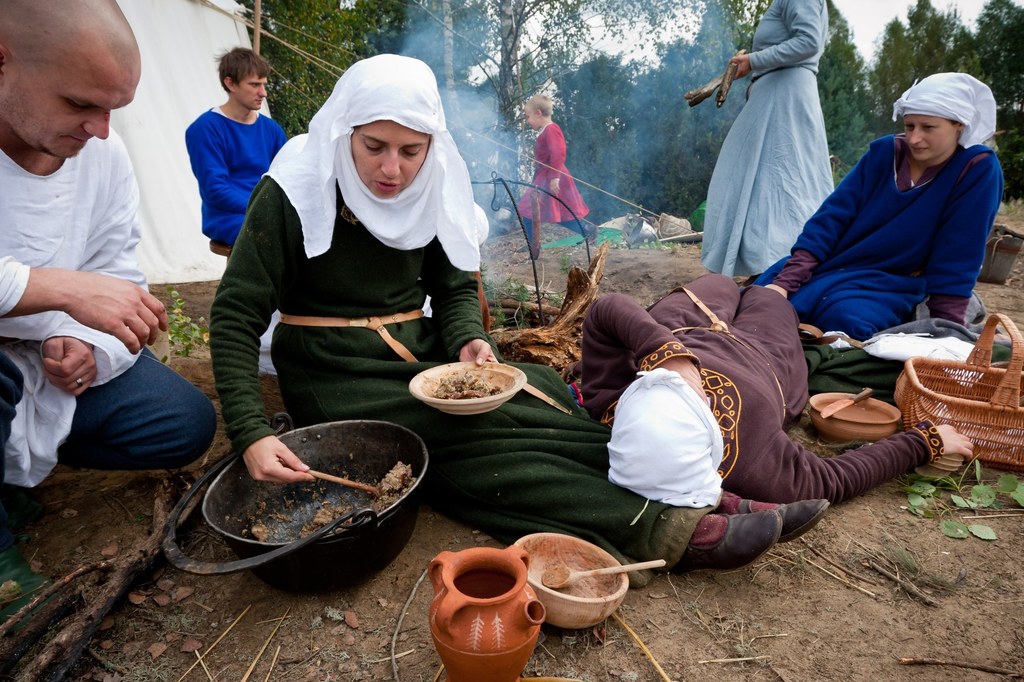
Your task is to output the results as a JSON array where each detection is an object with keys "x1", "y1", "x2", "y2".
[{"x1": 0, "y1": 349, "x2": 217, "y2": 551}]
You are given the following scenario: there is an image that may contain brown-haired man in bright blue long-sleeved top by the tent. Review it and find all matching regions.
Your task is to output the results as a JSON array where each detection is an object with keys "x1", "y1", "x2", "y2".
[{"x1": 185, "y1": 47, "x2": 287, "y2": 246}]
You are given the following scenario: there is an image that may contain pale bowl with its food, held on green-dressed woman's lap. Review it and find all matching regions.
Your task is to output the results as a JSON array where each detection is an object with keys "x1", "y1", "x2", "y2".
[{"x1": 409, "y1": 363, "x2": 526, "y2": 415}]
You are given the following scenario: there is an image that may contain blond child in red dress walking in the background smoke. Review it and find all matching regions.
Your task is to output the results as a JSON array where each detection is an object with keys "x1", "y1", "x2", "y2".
[{"x1": 519, "y1": 94, "x2": 590, "y2": 244}]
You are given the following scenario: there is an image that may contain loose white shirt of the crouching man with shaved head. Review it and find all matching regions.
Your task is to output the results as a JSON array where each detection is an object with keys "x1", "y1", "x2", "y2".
[{"x1": 0, "y1": 130, "x2": 146, "y2": 486}]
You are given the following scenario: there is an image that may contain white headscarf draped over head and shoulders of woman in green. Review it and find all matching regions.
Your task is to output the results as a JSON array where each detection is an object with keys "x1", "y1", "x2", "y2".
[{"x1": 267, "y1": 54, "x2": 480, "y2": 271}]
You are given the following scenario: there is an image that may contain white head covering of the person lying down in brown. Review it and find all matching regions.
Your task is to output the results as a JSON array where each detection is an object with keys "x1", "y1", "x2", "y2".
[{"x1": 608, "y1": 369, "x2": 723, "y2": 509}]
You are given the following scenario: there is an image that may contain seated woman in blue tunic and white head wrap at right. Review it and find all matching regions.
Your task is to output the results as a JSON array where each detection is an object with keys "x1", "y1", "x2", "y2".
[{"x1": 757, "y1": 73, "x2": 1002, "y2": 339}]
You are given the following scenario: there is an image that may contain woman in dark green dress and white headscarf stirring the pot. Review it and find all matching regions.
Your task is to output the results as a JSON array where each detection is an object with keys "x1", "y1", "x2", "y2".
[{"x1": 210, "y1": 54, "x2": 782, "y2": 579}]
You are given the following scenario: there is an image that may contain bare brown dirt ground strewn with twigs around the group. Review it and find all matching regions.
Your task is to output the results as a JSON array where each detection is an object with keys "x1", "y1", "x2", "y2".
[{"x1": 8, "y1": 215, "x2": 1024, "y2": 682}]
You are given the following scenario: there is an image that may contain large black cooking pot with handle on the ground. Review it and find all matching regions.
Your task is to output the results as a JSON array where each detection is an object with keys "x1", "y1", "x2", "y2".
[{"x1": 163, "y1": 417, "x2": 428, "y2": 592}]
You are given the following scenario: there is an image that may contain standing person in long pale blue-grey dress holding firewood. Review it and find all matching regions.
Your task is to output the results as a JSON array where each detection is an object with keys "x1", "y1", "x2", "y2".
[{"x1": 700, "y1": 0, "x2": 833, "y2": 275}]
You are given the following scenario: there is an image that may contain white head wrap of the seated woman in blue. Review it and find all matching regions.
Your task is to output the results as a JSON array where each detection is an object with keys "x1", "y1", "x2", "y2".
[{"x1": 893, "y1": 73, "x2": 995, "y2": 148}]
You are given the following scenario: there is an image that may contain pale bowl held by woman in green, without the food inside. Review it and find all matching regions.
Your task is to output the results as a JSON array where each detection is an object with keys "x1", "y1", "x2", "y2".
[{"x1": 409, "y1": 363, "x2": 526, "y2": 415}]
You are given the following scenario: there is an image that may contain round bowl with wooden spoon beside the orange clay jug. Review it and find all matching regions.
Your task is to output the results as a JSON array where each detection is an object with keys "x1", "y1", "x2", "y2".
[{"x1": 515, "y1": 532, "x2": 630, "y2": 630}]
